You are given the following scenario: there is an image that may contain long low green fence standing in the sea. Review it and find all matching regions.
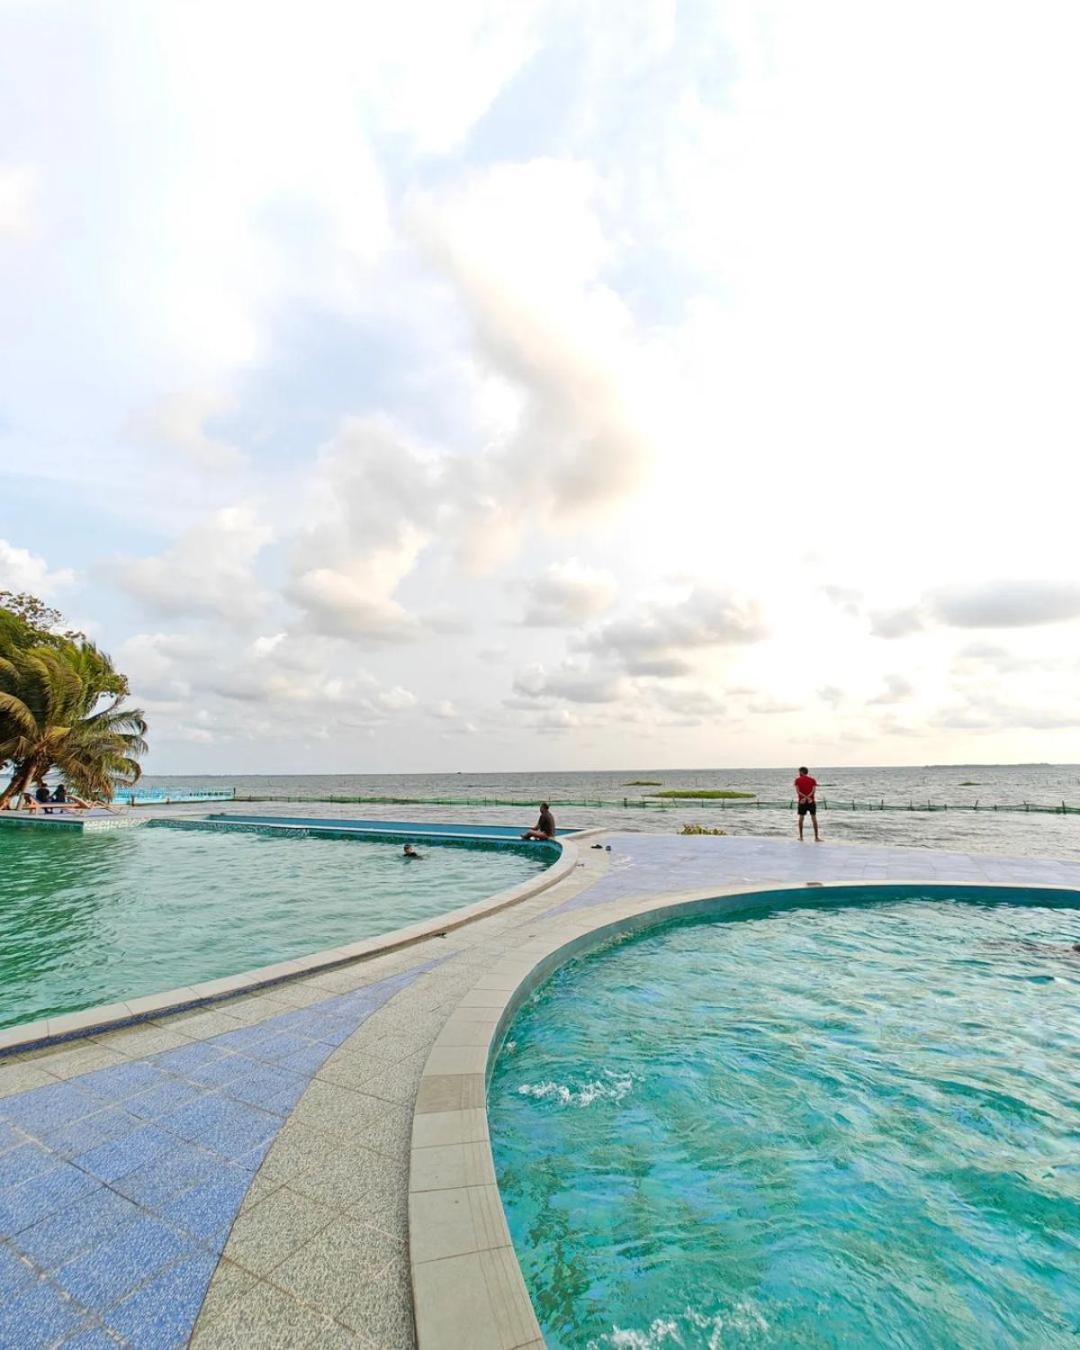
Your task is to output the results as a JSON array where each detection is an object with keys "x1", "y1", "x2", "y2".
[{"x1": 224, "y1": 794, "x2": 1080, "y2": 815}]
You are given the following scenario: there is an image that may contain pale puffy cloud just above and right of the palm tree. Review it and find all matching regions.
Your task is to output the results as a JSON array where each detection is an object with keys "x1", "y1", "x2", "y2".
[{"x1": 107, "y1": 506, "x2": 271, "y2": 624}]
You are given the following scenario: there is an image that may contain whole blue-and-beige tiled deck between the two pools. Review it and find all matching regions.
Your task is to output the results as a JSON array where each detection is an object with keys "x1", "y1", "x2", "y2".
[{"x1": 0, "y1": 833, "x2": 1080, "y2": 1350}]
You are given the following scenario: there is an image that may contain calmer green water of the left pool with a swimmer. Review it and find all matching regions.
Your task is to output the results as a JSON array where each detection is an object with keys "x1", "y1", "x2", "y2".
[{"x1": 0, "y1": 824, "x2": 554, "y2": 1026}]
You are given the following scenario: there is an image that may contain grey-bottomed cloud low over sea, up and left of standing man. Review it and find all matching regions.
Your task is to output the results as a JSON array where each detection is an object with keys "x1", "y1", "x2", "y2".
[{"x1": 582, "y1": 589, "x2": 765, "y2": 678}]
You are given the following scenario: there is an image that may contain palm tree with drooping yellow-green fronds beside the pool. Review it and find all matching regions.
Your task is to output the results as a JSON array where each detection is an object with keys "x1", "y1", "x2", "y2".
[{"x1": 0, "y1": 640, "x2": 146, "y2": 810}]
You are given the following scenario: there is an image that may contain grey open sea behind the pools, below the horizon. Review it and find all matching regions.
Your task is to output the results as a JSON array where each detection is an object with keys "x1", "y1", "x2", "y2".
[{"x1": 140, "y1": 764, "x2": 1080, "y2": 859}]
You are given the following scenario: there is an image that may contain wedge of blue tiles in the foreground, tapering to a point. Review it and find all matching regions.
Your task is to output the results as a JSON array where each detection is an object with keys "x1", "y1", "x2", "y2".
[{"x1": 0, "y1": 961, "x2": 439, "y2": 1350}]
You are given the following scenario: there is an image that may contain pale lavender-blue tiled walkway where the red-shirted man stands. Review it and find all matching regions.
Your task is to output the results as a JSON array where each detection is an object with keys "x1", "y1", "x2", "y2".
[{"x1": 544, "y1": 834, "x2": 1080, "y2": 918}]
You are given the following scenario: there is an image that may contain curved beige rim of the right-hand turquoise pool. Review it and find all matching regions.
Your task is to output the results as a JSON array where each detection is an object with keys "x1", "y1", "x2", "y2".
[{"x1": 408, "y1": 878, "x2": 1080, "y2": 1350}]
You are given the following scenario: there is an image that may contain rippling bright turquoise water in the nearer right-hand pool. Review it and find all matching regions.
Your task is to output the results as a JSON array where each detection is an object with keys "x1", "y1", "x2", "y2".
[{"x1": 489, "y1": 892, "x2": 1080, "y2": 1350}]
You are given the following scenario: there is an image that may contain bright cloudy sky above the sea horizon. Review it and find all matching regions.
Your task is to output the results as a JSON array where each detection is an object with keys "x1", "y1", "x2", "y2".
[{"x1": 0, "y1": 0, "x2": 1080, "y2": 775}]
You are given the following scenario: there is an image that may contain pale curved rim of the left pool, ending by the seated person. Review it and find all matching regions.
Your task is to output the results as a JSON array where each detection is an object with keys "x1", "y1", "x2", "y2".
[{"x1": 0, "y1": 821, "x2": 589, "y2": 1064}]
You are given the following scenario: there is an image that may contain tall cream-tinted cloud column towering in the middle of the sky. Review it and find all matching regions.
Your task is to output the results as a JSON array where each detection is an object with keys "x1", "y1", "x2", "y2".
[{"x1": 410, "y1": 159, "x2": 653, "y2": 558}]
